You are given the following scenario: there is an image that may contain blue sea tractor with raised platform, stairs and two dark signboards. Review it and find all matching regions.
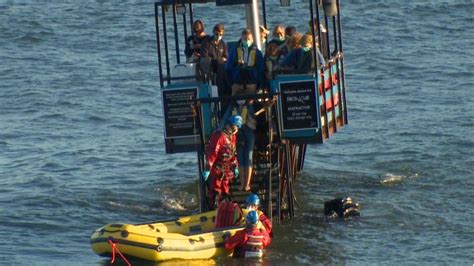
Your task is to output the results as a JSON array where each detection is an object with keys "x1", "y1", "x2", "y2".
[{"x1": 155, "y1": 0, "x2": 347, "y2": 222}]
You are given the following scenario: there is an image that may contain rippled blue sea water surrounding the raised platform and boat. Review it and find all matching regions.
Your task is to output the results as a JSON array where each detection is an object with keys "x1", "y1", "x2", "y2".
[{"x1": 0, "y1": 0, "x2": 474, "y2": 265}]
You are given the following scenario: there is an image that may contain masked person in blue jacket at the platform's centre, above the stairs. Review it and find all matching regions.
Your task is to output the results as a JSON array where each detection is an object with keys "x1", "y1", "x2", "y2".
[{"x1": 225, "y1": 29, "x2": 265, "y2": 95}]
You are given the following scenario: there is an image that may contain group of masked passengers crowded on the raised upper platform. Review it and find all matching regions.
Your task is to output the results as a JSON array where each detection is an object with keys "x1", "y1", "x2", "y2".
[{"x1": 185, "y1": 19, "x2": 328, "y2": 89}]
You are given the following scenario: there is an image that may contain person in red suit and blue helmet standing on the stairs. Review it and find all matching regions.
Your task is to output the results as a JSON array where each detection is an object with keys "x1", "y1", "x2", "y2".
[{"x1": 202, "y1": 115, "x2": 243, "y2": 209}]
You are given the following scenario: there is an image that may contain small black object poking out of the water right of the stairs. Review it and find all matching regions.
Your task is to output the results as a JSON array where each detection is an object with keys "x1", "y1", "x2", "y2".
[{"x1": 324, "y1": 197, "x2": 360, "y2": 218}]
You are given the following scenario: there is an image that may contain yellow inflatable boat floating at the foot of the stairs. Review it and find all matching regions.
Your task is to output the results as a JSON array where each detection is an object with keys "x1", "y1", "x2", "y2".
[{"x1": 90, "y1": 208, "x2": 248, "y2": 261}]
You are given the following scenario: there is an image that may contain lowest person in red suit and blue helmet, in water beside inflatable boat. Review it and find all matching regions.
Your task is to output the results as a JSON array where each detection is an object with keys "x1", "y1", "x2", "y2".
[{"x1": 224, "y1": 211, "x2": 271, "y2": 258}]
